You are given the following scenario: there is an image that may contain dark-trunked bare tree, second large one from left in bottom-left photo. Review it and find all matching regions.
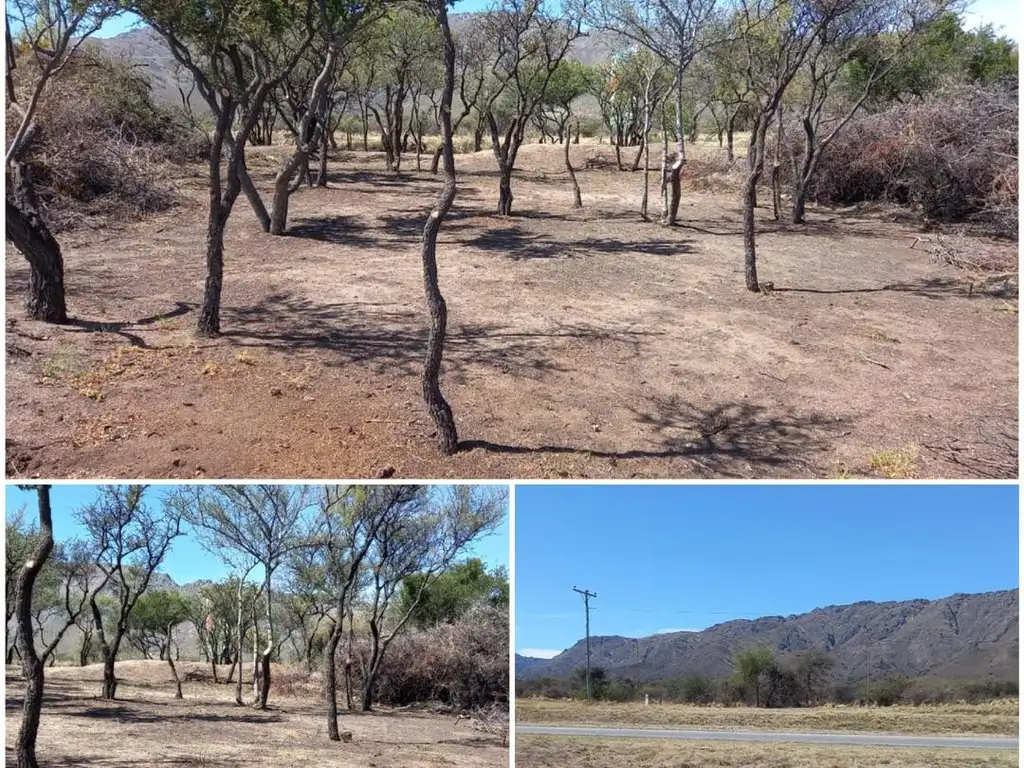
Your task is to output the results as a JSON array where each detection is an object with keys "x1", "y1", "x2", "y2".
[{"x1": 77, "y1": 485, "x2": 181, "y2": 699}]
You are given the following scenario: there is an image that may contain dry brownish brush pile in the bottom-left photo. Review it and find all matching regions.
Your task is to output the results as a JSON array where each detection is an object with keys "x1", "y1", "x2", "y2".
[{"x1": 350, "y1": 605, "x2": 509, "y2": 712}]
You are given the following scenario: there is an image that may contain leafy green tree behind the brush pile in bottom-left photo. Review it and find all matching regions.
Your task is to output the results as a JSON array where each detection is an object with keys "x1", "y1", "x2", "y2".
[{"x1": 397, "y1": 558, "x2": 509, "y2": 629}]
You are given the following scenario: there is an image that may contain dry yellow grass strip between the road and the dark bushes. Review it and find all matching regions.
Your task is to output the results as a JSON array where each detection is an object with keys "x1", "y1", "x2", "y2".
[{"x1": 515, "y1": 698, "x2": 1020, "y2": 736}]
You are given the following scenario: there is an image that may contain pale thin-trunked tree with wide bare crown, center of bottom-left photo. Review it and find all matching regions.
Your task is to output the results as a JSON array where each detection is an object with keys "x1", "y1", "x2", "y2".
[{"x1": 171, "y1": 485, "x2": 312, "y2": 710}]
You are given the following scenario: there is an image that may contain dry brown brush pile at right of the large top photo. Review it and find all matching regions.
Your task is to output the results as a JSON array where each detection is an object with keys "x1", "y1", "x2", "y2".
[{"x1": 790, "y1": 82, "x2": 1018, "y2": 239}]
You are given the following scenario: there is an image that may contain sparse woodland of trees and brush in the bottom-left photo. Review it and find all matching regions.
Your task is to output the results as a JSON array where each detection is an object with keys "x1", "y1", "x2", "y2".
[{"x1": 6, "y1": 485, "x2": 509, "y2": 766}]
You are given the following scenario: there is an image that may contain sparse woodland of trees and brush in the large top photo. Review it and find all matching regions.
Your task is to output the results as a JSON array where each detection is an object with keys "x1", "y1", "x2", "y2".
[{"x1": 6, "y1": 0, "x2": 1018, "y2": 475}]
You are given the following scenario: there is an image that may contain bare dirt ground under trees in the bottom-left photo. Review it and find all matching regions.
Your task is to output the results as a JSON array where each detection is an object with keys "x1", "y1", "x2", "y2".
[{"x1": 6, "y1": 662, "x2": 509, "y2": 768}]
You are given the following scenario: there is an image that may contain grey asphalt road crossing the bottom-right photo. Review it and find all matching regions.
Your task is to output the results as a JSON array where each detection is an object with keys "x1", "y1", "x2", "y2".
[{"x1": 515, "y1": 725, "x2": 1018, "y2": 750}]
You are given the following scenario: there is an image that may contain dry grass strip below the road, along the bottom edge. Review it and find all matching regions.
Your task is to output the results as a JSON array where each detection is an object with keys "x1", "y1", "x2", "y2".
[{"x1": 515, "y1": 736, "x2": 1017, "y2": 768}]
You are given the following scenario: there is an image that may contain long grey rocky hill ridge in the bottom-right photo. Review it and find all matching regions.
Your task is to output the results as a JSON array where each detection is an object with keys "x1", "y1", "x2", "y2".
[{"x1": 516, "y1": 590, "x2": 1020, "y2": 681}]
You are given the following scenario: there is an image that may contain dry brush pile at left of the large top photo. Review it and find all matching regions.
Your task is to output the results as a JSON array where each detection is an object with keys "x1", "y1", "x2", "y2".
[{"x1": 6, "y1": 49, "x2": 208, "y2": 231}]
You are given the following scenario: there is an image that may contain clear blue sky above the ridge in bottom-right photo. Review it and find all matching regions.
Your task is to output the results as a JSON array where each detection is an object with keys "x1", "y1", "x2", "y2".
[{"x1": 515, "y1": 484, "x2": 1020, "y2": 656}]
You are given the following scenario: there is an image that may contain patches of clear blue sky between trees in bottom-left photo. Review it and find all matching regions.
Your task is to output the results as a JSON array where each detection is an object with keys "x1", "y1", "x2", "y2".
[{"x1": 6, "y1": 484, "x2": 509, "y2": 584}]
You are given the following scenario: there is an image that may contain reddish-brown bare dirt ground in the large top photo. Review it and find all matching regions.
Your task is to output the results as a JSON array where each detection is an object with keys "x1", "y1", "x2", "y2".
[{"x1": 6, "y1": 145, "x2": 1018, "y2": 478}]
